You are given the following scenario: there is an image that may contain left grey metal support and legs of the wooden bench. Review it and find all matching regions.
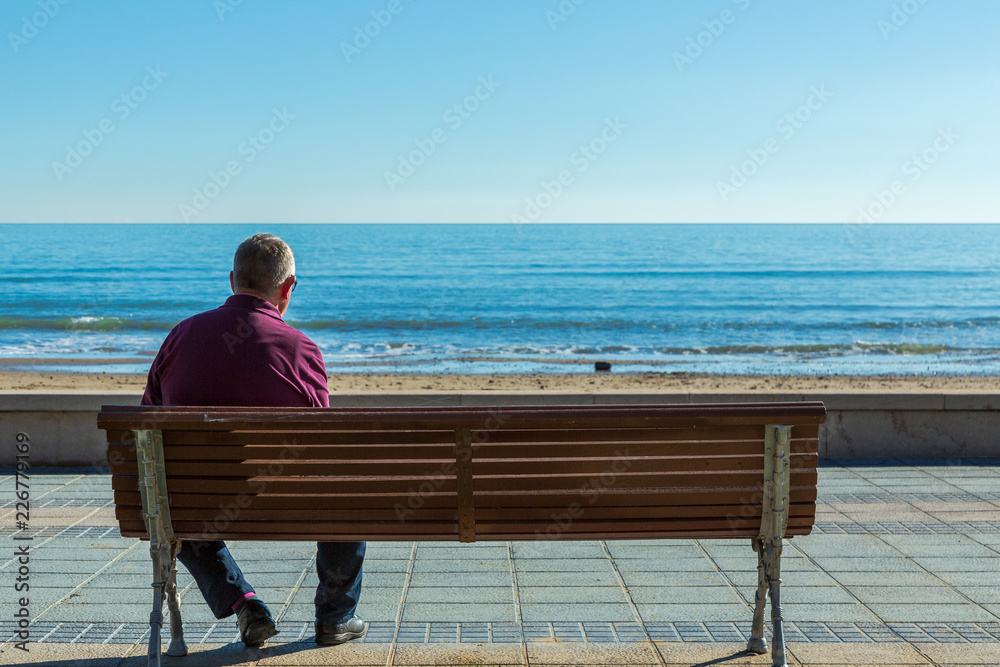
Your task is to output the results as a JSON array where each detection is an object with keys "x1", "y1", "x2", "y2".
[{"x1": 134, "y1": 431, "x2": 187, "y2": 667}]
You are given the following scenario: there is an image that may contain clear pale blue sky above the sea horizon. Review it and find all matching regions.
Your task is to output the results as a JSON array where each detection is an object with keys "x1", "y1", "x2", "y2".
[{"x1": 0, "y1": 0, "x2": 1000, "y2": 223}]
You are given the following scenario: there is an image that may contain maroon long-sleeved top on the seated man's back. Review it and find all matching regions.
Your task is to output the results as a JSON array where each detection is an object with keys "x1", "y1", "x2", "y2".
[{"x1": 142, "y1": 294, "x2": 330, "y2": 408}]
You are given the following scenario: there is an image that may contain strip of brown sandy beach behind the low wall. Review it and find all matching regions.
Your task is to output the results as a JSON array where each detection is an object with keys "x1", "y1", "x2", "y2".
[{"x1": 0, "y1": 367, "x2": 1000, "y2": 394}]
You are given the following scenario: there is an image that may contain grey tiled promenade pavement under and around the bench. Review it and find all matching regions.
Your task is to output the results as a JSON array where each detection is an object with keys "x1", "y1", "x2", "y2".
[{"x1": 0, "y1": 459, "x2": 1000, "y2": 667}]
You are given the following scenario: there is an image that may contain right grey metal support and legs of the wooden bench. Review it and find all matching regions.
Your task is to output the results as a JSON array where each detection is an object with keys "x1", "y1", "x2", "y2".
[{"x1": 747, "y1": 424, "x2": 792, "y2": 667}]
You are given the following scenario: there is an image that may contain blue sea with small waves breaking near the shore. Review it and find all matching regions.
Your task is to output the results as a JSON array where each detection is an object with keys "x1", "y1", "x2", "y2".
[{"x1": 0, "y1": 224, "x2": 1000, "y2": 375}]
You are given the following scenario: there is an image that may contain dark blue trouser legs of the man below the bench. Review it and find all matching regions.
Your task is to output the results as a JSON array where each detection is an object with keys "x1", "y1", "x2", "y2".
[{"x1": 177, "y1": 540, "x2": 366, "y2": 623}]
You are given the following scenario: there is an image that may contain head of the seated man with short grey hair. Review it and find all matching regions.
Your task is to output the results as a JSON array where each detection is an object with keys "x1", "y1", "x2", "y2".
[{"x1": 229, "y1": 234, "x2": 295, "y2": 315}]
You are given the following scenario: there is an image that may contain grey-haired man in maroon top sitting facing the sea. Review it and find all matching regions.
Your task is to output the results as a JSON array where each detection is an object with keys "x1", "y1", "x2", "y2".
[{"x1": 142, "y1": 234, "x2": 367, "y2": 647}]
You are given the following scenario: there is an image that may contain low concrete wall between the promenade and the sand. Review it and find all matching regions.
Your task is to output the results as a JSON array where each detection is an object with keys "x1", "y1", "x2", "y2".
[{"x1": 0, "y1": 391, "x2": 1000, "y2": 466}]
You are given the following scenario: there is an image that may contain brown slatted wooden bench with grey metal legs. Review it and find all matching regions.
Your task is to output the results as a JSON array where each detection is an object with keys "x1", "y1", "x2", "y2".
[{"x1": 98, "y1": 402, "x2": 826, "y2": 665}]
